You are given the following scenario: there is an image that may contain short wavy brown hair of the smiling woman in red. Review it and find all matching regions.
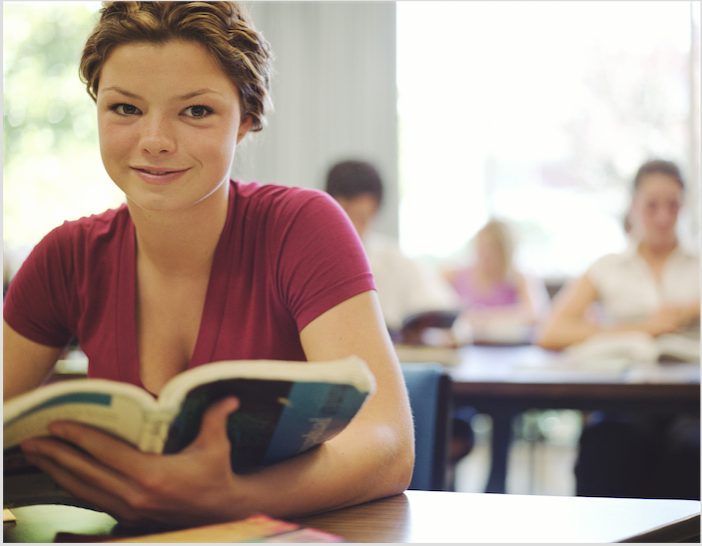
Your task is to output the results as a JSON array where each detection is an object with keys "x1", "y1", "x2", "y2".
[{"x1": 80, "y1": 2, "x2": 273, "y2": 131}]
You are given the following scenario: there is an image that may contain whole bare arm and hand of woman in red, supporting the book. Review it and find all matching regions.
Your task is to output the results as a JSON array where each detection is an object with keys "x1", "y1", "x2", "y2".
[{"x1": 23, "y1": 291, "x2": 414, "y2": 525}]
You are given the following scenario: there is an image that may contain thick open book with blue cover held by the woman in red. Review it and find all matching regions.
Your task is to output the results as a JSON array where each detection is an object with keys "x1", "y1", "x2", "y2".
[{"x1": 3, "y1": 356, "x2": 375, "y2": 507}]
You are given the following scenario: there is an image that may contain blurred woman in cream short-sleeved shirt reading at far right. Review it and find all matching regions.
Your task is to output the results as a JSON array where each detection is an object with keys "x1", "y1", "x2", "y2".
[{"x1": 538, "y1": 161, "x2": 700, "y2": 350}]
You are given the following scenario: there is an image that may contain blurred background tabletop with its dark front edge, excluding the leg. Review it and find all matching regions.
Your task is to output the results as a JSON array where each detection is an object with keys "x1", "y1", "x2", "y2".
[{"x1": 447, "y1": 345, "x2": 700, "y2": 411}]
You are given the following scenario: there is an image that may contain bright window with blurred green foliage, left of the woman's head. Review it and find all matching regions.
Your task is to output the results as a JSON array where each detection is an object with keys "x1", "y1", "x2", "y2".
[{"x1": 3, "y1": 2, "x2": 124, "y2": 276}]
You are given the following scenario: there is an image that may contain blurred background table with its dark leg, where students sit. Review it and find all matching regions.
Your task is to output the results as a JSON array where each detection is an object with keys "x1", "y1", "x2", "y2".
[{"x1": 448, "y1": 345, "x2": 700, "y2": 493}]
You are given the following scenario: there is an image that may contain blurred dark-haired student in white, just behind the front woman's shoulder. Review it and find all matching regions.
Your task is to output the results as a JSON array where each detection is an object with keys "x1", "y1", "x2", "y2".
[{"x1": 325, "y1": 160, "x2": 457, "y2": 331}]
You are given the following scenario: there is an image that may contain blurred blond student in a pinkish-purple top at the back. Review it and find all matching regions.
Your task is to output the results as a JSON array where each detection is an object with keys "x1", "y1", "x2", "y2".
[{"x1": 445, "y1": 220, "x2": 549, "y2": 341}]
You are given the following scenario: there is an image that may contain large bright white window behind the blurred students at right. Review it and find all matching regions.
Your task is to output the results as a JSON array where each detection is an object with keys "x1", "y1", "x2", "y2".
[{"x1": 397, "y1": 1, "x2": 700, "y2": 278}]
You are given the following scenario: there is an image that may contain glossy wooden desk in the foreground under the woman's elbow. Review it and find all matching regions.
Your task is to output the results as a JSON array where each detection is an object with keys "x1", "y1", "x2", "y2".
[{"x1": 3, "y1": 491, "x2": 700, "y2": 544}]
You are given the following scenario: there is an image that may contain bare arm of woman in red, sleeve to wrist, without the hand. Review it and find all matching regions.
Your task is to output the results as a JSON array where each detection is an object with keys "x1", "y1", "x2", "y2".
[{"x1": 236, "y1": 291, "x2": 414, "y2": 517}]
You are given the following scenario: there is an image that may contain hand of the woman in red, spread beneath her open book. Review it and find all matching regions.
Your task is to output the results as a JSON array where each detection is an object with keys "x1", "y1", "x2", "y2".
[{"x1": 22, "y1": 397, "x2": 249, "y2": 526}]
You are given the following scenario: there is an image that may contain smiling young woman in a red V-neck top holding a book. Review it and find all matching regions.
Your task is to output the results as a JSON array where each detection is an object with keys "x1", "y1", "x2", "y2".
[{"x1": 3, "y1": 2, "x2": 413, "y2": 525}]
